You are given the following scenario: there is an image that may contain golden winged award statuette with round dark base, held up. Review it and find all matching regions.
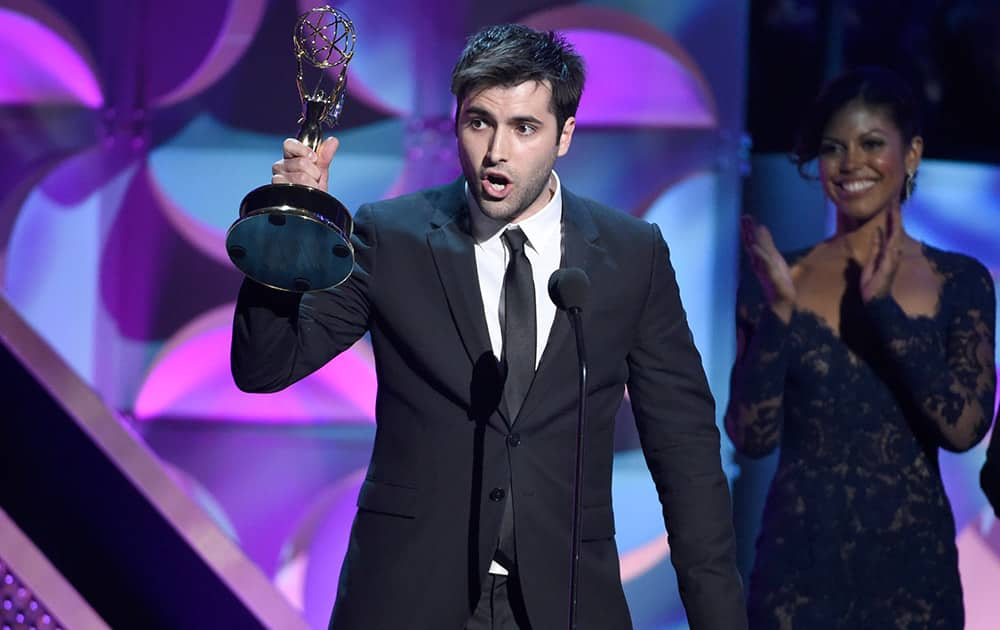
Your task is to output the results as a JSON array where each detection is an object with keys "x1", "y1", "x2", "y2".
[{"x1": 226, "y1": 6, "x2": 356, "y2": 293}]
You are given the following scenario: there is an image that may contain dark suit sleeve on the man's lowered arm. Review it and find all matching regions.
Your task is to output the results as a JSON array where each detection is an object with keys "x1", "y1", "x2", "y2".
[{"x1": 628, "y1": 225, "x2": 747, "y2": 630}]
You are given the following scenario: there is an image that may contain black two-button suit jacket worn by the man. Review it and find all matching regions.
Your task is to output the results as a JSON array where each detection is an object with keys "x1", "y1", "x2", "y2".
[{"x1": 232, "y1": 180, "x2": 746, "y2": 630}]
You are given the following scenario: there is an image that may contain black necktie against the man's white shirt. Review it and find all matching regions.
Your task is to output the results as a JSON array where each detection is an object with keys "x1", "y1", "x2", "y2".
[{"x1": 501, "y1": 228, "x2": 537, "y2": 422}]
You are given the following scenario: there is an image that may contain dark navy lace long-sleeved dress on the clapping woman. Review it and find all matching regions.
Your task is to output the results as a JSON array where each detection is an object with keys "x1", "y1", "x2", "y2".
[{"x1": 726, "y1": 245, "x2": 996, "y2": 630}]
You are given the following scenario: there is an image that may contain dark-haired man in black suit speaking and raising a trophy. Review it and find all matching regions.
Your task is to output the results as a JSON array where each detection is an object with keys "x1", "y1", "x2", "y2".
[{"x1": 232, "y1": 25, "x2": 746, "y2": 630}]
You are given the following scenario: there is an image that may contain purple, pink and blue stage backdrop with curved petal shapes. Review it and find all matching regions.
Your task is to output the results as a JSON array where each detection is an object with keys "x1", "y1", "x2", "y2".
[{"x1": 0, "y1": 0, "x2": 1000, "y2": 629}]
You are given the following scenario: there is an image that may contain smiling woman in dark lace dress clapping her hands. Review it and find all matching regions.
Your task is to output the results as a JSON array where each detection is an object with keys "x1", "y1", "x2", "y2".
[{"x1": 726, "y1": 69, "x2": 996, "y2": 630}]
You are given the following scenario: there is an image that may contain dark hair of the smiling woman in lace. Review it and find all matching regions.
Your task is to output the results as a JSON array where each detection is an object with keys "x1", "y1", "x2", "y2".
[{"x1": 792, "y1": 66, "x2": 921, "y2": 177}]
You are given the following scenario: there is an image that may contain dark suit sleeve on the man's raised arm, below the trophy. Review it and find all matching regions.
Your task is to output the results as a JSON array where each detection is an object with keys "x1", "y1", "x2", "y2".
[{"x1": 231, "y1": 206, "x2": 378, "y2": 392}]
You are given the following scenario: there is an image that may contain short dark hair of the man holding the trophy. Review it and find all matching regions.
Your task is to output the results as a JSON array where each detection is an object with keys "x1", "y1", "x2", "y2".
[{"x1": 451, "y1": 24, "x2": 585, "y2": 142}]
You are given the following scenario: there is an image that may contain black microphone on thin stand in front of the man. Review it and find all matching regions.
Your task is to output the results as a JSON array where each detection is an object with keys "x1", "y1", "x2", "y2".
[{"x1": 549, "y1": 267, "x2": 590, "y2": 630}]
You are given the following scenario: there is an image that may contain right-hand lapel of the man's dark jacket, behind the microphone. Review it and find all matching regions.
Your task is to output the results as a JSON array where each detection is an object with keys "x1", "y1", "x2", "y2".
[{"x1": 518, "y1": 187, "x2": 606, "y2": 424}]
